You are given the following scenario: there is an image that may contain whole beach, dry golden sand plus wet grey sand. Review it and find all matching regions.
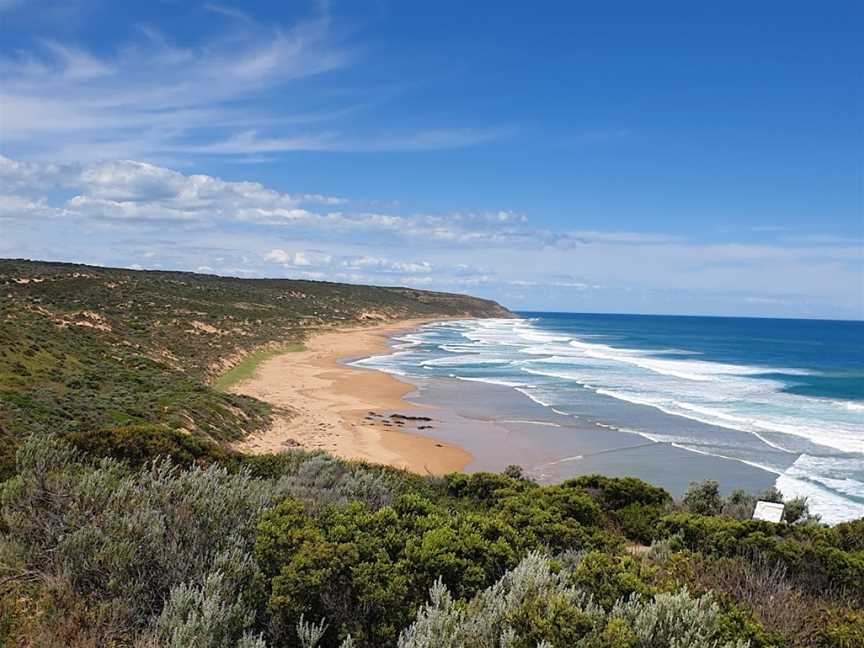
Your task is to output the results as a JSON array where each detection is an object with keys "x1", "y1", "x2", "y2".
[{"x1": 231, "y1": 318, "x2": 776, "y2": 504}]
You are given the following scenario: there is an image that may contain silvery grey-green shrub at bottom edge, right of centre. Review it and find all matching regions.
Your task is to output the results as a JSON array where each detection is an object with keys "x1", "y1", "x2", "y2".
[{"x1": 398, "y1": 553, "x2": 747, "y2": 648}]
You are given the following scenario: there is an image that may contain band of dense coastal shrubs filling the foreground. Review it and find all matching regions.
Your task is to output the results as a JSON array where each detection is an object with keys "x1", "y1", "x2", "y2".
[{"x1": 0, "y1": 436, "x2": 864, "y2": 648}]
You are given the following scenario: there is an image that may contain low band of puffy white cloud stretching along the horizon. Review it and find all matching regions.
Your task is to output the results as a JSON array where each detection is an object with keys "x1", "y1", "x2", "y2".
[{"x1": 0, "y1": 156, "x2": 864, "y2": 317}]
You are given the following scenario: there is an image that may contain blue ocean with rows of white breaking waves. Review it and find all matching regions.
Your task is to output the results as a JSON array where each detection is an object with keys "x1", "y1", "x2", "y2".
[{"x1": 358, "y1": 313, "x2": 864, "y2": 522}]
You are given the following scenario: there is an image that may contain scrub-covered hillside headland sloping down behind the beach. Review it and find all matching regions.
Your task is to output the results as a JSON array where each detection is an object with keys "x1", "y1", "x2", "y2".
[{"x1": 0, "y1": 260, "x2": 509, "y2": 474}]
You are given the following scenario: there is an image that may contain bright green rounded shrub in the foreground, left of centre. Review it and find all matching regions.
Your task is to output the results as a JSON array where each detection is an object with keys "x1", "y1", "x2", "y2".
[{"x1": 255, "y1": 495, "x2": 518, "y2": 646}]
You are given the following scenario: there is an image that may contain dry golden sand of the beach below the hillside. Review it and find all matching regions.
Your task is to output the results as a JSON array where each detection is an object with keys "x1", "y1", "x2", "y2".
[{"x1": 232, "y1": 320, "x2": 472, "y2": 474}]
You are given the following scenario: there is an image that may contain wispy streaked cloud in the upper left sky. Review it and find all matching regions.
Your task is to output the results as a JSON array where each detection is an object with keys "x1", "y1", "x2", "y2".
[{"x1": 0, "y1": 5, "x2": 507, "y2": 161}]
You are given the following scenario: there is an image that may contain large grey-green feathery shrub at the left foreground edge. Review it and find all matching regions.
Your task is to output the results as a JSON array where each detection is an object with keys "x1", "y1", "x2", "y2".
[{"x1": 2, "y1": 436, "x2": 290, "y2": 635}]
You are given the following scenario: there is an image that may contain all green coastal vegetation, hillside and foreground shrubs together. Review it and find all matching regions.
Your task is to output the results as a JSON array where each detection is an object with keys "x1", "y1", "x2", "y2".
[{"x1": 0, "y1": 262, "x2": 864, "y2": 648}]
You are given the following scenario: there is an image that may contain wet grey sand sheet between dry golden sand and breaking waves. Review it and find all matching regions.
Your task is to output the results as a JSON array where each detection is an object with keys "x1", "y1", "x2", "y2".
[{"x1": 398, "y1": 377, "x2": 777, "y2": 496}]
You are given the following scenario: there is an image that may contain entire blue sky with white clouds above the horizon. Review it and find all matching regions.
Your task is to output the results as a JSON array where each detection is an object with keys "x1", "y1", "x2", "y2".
[{"x1": 0, "y1": 0, "x2": 864, "y2": 319}]
